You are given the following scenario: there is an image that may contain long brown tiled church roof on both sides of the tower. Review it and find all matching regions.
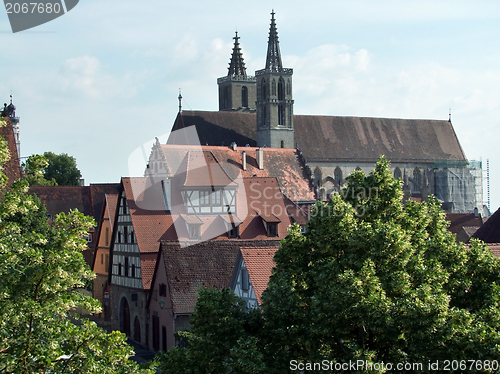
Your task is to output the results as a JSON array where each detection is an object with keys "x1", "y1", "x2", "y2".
[{"x1": 168, "y1": 111, "x2": 466, "y2": 163}]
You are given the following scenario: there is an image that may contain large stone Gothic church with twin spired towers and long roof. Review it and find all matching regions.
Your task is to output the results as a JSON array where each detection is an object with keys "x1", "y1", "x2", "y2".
[{"x1": 167, "y1": 11, "x2": 483, "y2": 213}]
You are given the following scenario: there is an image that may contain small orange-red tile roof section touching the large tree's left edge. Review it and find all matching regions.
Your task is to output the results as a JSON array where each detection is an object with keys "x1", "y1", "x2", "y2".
[{"x1": 241, "y1": 247, "x2": 279, "y2": 305}]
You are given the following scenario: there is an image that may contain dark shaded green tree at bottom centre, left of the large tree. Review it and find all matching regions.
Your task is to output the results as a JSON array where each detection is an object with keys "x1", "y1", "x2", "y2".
[{"x1": 157, "y1": 287, "x2": 266, "y2": 374}]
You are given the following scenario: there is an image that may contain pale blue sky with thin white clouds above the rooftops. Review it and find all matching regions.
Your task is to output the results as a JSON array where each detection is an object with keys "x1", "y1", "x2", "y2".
[{"x1": 0, "y1": 0, "x2": 500, "y2": 211}]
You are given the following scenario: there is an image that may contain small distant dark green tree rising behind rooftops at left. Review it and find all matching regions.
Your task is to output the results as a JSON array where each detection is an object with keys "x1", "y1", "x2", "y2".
[{"x1": 43, "y1": 152, "x2": 82, "y2": 186}]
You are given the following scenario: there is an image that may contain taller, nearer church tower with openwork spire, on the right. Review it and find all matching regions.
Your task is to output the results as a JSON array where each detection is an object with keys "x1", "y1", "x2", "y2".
[{"x1": 255, "y1": 10, "x2": 294, "y2": 148}]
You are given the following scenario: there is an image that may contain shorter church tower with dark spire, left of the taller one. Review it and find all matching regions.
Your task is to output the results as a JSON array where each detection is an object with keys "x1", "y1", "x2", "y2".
[{"x1": 217, "y1": 31, "x2": 256, "y2": 111}]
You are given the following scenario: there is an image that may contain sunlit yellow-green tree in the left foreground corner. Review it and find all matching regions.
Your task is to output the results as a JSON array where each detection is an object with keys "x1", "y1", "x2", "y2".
[{"x1": 0, "y1": 117, "x2": 154, "y2": 374}]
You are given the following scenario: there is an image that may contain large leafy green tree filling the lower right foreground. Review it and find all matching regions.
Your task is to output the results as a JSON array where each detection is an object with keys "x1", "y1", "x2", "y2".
[{"x1": 262, "y1": 158, "x2": 500, "y2": 373}]
